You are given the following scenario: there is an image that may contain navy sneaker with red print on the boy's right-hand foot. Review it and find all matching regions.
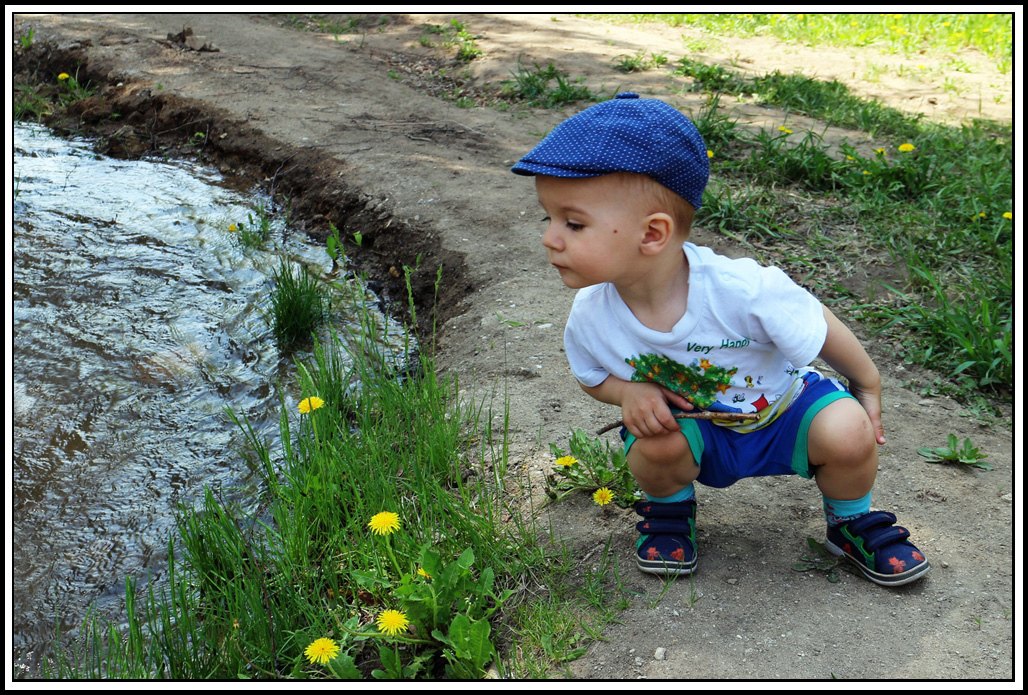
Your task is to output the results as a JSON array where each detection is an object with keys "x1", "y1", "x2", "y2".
[{"x1": 824, "y1": 512, "x2": 931, "y2": 586}]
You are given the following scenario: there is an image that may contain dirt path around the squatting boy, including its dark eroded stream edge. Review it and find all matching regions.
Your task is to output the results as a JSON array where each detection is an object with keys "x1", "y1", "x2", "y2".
[{"x1": 15, "y1": 13, "x2": 1020, "y2": 680}]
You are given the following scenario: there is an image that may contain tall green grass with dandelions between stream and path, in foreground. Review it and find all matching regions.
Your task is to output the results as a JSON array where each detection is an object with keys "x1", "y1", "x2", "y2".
[{"x1": 36, "y1": 289, "x2": 624, "y2": 680}]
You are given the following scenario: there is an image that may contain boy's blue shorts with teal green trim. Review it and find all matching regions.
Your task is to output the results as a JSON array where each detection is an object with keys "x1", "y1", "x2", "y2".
[{"x1": 621, "y1": 371, "x2": 853, "y2": 487}]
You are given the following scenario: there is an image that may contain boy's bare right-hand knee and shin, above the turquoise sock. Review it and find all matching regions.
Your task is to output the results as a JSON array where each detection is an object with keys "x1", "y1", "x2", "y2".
[{"x1": 807, "y1": 398, "x2": 878, "y2": 500}]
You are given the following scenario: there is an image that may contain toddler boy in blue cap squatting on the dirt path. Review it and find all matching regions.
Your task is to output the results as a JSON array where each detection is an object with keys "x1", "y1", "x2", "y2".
[{"x1": 511, "y1": 93, "x2": 930, "y2": 586}]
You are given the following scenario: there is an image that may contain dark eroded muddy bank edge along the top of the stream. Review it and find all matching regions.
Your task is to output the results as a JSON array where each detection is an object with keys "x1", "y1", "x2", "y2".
[{"x1": 13, "y1": 41, "x2": 474, "y2": 335}]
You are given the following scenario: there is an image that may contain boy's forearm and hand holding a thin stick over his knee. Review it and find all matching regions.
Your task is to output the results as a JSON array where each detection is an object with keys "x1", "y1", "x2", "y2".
[{"x1": 579, "y1": 375, "x2": 693, "y2": 437}]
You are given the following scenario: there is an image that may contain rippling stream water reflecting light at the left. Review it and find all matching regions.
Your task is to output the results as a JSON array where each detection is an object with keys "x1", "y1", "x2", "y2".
[{"x1": 7, "y1": 124, "x2": 403, "y2": 657}]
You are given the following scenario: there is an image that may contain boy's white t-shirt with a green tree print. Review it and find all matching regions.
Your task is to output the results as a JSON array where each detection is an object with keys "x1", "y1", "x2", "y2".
[{"x1": 564, "y1": 243, "x2": 828, "y2": 412}]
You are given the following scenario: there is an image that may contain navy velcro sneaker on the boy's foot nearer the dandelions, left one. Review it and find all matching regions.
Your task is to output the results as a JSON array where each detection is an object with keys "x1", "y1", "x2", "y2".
[{"x1": 635, "y1": 499, "x2": 696, "y2": 575}]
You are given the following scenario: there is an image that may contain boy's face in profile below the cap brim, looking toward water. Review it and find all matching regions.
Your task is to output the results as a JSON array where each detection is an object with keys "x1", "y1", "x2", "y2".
[{"x1": 536, "y1": 176, "x2": 646, "y2": 289}]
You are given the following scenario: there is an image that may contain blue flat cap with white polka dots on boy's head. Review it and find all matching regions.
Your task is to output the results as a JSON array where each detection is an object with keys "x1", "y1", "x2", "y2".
[{"x1": 511, "y1": 92, "x2": 710, "y2": 209}]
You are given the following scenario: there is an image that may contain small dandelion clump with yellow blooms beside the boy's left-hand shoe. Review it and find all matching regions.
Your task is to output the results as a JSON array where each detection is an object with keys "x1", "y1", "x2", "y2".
[{"x1": 546, "y1": 430, "x2": 641, "y2": 507}]
